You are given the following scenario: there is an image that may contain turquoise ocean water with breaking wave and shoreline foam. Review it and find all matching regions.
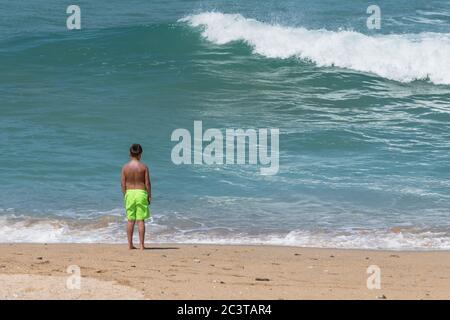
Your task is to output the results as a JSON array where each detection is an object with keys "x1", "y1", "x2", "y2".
[{"x1": 0, "y1": 0, "x2": 450, "y2": 249}]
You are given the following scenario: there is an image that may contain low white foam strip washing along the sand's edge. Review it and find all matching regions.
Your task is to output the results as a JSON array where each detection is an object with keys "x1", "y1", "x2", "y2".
[{"x1": 0, "y1": 216, "x2": 450, "y2": 250}]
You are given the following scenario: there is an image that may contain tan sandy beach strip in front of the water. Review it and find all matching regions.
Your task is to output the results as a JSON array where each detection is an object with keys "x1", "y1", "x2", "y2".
[{"x1": 0, "y1": 244, "x2": 450, "y2": 299}]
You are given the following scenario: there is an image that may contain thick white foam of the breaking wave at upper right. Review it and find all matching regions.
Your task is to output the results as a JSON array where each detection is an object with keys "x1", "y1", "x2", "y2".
[{"x1": 180, "y1": 12, "x2": 450, "y2": 85}]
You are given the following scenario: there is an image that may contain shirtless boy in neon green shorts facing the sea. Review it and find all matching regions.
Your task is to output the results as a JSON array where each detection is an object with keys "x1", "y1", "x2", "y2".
[{"x1": 121, "y1": 144, "x2": 152, "y2": 250}]
